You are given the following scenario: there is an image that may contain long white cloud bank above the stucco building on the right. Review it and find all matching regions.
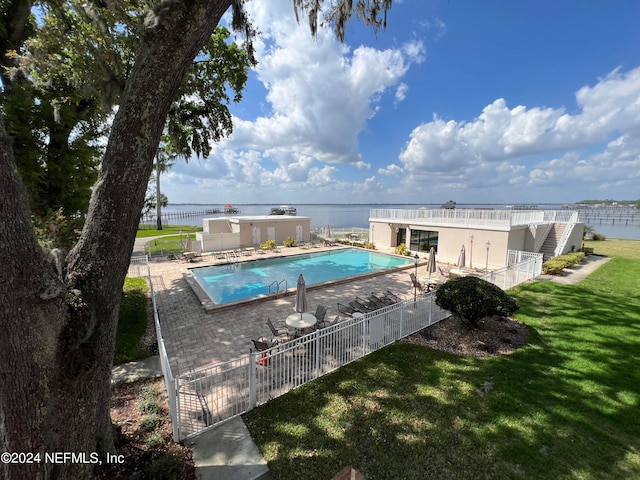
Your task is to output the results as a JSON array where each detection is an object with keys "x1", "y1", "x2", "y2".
[{"x1": 399, "y1": 68, "x2": 640, "y2": 193}]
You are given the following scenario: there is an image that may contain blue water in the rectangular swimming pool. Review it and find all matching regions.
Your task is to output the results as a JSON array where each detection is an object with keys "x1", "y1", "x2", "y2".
[{"x1": 191, "y1": 248, "x2": 413, "y2": 304}]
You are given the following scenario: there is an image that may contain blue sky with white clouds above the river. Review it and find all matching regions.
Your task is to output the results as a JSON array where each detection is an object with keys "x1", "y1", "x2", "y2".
[{"x1": 161, "y1": 0, "x2": 640, "y2": 205}]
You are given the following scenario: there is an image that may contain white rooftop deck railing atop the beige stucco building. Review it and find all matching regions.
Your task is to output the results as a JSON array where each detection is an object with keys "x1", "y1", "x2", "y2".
[{"x1": 369, "y1": 208, "x2": 578, "y2": 227}]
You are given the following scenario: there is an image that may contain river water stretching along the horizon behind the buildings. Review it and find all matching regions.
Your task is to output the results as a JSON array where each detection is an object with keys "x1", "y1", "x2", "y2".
[{"x1": 148, "y1": 204, "x2": 640, "y2": 240}]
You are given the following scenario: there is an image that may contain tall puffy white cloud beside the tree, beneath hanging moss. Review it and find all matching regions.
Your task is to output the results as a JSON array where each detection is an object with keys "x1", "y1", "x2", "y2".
[{"x1": 226, "y1": 2, "x2": 424, "y2": 167}]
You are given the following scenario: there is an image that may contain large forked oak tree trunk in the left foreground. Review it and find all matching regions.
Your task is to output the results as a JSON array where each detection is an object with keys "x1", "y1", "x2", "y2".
[{"x1": 0, "y1": 0, "x2": 231, "y2": 480}]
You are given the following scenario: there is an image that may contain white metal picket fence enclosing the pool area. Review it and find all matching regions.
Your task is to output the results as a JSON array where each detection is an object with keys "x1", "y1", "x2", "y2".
[{"x1": 132, "y1": 252, "x2": 542, "y2": 441}]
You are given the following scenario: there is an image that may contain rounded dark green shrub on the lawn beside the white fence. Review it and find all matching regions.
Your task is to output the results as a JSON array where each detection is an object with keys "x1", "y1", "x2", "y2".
[{"x1": 436, "y1": 276, "x2": 519, "y2": 326}]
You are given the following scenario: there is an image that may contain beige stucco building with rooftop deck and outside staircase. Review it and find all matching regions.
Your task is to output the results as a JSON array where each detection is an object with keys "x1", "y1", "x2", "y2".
[{"x1": 369, "y1": 208, "x2": 584, "y2": 269}]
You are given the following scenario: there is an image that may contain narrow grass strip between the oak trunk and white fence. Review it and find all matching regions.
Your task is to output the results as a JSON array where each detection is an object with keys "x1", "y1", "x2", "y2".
[{"x1": 113, "y1": 278, "x2": 149, "y2": 365}]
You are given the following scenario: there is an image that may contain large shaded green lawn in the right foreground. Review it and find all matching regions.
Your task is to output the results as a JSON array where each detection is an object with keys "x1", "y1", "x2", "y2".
[{"x1": 245, "y1": 240, "x2": 640, "y2": 480}]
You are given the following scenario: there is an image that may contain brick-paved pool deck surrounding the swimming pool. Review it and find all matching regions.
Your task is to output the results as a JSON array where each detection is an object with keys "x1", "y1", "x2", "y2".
[{"x1": 141, "y1": 246, "x2": 450, "y2": 376}]
